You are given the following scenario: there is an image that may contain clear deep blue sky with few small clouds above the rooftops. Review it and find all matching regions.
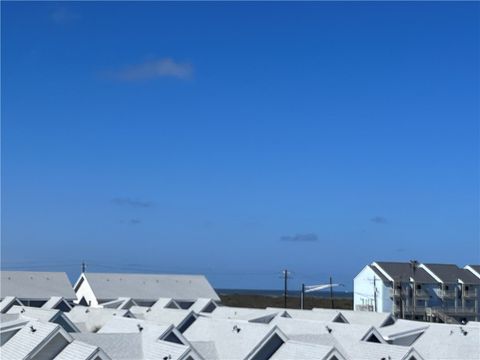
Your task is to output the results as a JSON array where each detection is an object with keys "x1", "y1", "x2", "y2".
[{"x1": 1, "y1": 2, "x2": 480, "y2": 288}]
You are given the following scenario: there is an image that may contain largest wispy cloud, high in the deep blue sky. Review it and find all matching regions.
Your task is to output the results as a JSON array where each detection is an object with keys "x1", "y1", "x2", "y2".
[{"x1": 110, "y1": 58, "x2": 193, "y2": 81}]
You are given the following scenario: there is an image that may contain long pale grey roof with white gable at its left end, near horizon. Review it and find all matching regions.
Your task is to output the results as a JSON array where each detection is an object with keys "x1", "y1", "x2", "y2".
[{"x1": 82, "y1": 273, "x2": 220, "y2": 301}]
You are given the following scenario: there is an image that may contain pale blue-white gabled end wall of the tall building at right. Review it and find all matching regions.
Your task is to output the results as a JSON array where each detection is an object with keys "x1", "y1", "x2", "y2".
[{"x1": 353, "y1": 266, "x2": 392, "y2": 312}]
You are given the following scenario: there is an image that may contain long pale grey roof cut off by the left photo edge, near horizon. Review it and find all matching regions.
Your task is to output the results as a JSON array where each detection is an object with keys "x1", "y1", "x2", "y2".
[{"x1": 0, "y1": 271, "x2": 77, "y2": 301}]
